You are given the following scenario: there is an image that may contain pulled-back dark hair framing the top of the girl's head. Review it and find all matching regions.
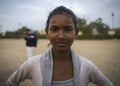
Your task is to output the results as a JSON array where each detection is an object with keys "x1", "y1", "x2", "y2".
[{"x1": 45, "y1": 6, "x2": 77, "y2": 30}]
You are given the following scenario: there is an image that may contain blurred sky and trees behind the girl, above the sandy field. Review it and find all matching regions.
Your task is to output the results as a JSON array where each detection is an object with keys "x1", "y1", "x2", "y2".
[{"x1": 0, "y1": 0, "x2": 120, "y2": 39}]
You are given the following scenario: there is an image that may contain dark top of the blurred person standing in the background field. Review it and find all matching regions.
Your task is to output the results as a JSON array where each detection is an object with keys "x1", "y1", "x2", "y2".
[{"x1": 24, "y1": 33, "x2": 38, "y2": 47}]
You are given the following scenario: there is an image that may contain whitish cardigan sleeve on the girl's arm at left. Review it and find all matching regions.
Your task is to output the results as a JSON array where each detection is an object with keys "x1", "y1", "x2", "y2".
[{"x1": 6, "y1": 60, "x2": 31, "y2": 86}]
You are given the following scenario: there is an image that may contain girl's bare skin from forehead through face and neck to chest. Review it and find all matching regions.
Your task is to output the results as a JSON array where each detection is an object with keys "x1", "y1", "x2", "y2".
[{"x1": 46, "y1": 14, "x2": 77, "y2": 81}]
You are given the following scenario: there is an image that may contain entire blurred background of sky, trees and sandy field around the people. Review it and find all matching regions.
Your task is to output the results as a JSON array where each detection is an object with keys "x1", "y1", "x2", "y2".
[{"x1": 0, "y1": 0, "x2": 120, "y2": 86}]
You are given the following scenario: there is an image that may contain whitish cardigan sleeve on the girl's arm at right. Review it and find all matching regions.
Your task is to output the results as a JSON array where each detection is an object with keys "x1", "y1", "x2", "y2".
[{"x1": 90, "y1": 62, "x2": 113, "y2": 86}]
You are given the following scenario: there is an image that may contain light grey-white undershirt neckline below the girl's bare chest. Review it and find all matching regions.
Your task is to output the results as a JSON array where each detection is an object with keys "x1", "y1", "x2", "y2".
[{"x1": 51, "y1": 78, "x2": 74, "y2": 86}]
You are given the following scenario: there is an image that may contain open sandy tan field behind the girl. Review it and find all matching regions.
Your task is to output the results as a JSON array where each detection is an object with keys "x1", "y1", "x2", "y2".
[{"x1": 0, "y1": 39, "x2": 120, "y2": 86}]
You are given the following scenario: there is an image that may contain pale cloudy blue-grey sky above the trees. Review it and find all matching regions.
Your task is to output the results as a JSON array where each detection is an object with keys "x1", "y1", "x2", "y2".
[{"x1": 0, "y1": 0, "x2": 120, "y2": 32}]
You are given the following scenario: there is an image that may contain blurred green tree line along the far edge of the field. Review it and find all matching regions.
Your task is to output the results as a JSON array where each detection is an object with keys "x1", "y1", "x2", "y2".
[{"x1": 0, "y1": 18, "x2": 120, "y2": 39}]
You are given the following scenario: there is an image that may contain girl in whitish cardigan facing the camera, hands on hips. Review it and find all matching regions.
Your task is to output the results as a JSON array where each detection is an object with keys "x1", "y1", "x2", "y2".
[{"x1": 7, "y1": 6, "x2": 113, "y2": 86}]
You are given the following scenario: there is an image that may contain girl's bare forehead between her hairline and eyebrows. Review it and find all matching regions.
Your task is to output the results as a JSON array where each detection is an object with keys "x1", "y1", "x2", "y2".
[{"x1": 50, "y1": 14, "x2": 74, "y2": 24}]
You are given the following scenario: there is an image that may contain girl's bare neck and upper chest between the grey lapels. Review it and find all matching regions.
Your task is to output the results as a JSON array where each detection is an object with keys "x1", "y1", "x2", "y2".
[{"x1": 53, "y1": 49, "x2": 73, "y2": 81}]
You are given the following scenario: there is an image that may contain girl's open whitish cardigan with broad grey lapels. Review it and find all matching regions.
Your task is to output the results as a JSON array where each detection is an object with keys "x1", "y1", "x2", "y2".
[{"x1": 6, "y1": 49, "x2": 113, "y2": 86}]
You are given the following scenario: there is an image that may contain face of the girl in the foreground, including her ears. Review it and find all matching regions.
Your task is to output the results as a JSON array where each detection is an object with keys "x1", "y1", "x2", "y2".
[{"x1": 46, "y1": 14, "x2": 77, "y2": 51}]
